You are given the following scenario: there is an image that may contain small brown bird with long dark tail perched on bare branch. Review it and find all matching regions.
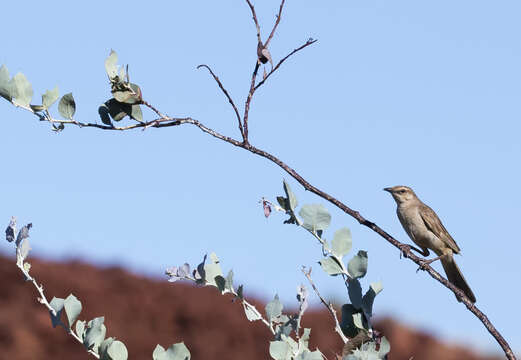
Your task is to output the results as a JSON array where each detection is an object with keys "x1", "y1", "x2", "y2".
[{"x1": 384, "y1": 185, "x2": 476, "y2": 303}]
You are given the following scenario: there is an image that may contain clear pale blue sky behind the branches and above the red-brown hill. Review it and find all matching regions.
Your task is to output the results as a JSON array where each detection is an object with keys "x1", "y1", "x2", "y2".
[{"x1": 0, "y1": 0, "x2": 521, "y2": 352}]
